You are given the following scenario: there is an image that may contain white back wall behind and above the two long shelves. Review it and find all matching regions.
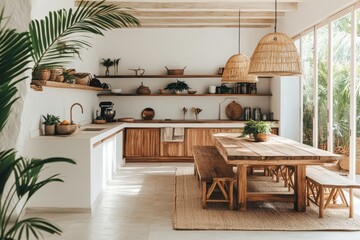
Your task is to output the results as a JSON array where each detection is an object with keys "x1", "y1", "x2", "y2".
[{"x1": 98, "y1": 29, "x2": 270, "y2": 119}]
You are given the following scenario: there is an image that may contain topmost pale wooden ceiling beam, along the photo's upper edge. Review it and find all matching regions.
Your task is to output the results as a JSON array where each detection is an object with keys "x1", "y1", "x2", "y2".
[{"x1": 76, "y1": 1, "x2": 297, "y2": 12}]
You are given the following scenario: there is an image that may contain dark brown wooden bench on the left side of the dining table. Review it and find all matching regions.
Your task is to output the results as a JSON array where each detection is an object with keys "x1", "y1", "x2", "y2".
[{"x1": 193, "y1": 146, "x2": 235, "y2": 210}]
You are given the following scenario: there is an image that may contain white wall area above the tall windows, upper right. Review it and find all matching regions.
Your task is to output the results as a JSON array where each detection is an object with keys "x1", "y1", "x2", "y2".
[{"x1": 278, "y1": 0, "x2": 357, "y2": 36}]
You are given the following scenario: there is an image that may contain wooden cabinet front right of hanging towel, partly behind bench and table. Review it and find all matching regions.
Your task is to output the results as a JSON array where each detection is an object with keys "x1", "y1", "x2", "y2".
[{"x1": 185, "y1": 128, "x2": 242, "y2": 157}]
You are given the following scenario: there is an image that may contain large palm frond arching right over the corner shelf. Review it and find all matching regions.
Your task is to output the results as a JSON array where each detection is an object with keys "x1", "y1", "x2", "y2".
[{"x1": 30, "y1": 1, "x2": 140, "y2": 69}]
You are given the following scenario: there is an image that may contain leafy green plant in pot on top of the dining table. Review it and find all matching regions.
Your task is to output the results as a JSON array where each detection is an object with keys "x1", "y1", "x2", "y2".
[{"x1": 241, "y1": 120, "x2": 271, "y2": 142}]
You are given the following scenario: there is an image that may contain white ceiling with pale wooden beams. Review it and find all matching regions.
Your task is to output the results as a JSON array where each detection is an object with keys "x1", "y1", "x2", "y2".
[{"x1": 77, "y1": 0, "x2": 305, "y2": 28}]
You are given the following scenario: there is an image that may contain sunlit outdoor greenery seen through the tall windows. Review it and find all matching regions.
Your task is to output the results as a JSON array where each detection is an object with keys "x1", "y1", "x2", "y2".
[{"x1": 302, "y1": 11, "x2": 360, "y2": 155}]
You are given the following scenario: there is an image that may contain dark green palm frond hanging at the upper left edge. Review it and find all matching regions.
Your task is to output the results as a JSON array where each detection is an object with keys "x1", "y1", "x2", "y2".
[{"x1": 0, "y1": 9, "x2": 31, "y2": 131}]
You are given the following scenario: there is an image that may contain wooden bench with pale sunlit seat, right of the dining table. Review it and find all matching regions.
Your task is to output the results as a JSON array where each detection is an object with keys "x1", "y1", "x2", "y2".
[{"x1": 306, "y1": 166, "x2": 360, "y2": 218}]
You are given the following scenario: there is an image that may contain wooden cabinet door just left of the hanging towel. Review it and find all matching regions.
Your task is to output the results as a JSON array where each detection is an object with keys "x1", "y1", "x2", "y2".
[{"x1": 125, "y1": 128, "x2": 160, "y2": 157}]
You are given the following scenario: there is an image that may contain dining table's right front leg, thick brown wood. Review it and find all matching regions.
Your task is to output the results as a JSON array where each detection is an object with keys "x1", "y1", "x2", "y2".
[{"x1": 294, "y1": 165, "x2": 306, "y2": 212}]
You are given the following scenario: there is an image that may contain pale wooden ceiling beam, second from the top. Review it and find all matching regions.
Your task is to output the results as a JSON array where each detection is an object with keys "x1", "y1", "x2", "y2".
[{"x1": 129, "y1": 10, "x2": 285, "y2": 19}]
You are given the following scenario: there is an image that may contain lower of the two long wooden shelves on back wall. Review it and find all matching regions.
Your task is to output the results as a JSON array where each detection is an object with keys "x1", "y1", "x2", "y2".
[{"x1": 98, "y1": 93, "x2": 272, "y2": 97}]
